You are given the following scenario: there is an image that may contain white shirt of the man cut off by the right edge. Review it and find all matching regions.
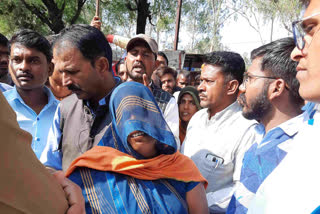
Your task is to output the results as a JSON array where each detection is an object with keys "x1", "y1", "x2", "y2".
[{"x1": 248, "y1": 109, "x2": 320, "y2": 214}]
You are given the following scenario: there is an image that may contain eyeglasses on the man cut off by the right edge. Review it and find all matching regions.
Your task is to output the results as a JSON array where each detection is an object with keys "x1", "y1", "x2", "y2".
[{"x1": 292, "y1": 12, "x2": 320, "y2": 50}]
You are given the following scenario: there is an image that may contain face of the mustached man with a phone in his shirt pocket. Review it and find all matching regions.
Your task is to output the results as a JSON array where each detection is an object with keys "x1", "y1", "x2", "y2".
[{"x1": 198, "y1": 64, "x2": 227, "y2": 111}]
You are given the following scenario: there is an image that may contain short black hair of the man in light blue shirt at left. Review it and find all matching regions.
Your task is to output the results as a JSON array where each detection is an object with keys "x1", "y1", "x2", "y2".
[{"x1": 9, "y1": 29, "x2": 52, "y2": 62}]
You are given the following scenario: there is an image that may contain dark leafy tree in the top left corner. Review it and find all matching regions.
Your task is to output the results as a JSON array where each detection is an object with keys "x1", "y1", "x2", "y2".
[{"x1": 0, "y1": 0, "x2": 86, "y2": 34}]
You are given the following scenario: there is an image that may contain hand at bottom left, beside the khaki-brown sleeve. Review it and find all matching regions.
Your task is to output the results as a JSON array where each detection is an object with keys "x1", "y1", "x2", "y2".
[{"x1": 53, "y1": 171, "x2": 86, "y2": 214}]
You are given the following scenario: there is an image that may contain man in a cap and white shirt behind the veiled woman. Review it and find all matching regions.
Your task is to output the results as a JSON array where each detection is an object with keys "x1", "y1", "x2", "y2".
[{"x1": 125, "y1": 34, "x2": 180, "y2": 148}]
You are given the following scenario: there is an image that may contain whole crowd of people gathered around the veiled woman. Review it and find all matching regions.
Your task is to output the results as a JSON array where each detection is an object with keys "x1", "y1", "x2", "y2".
[{"x1": 0, "y1": 0, "x2": 320, "y2": 214}]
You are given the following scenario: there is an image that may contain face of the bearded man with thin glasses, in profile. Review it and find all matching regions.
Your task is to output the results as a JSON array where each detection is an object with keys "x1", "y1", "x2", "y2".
[{"x1": 238, "y1": 58, "x2": 271, "y2": 120}]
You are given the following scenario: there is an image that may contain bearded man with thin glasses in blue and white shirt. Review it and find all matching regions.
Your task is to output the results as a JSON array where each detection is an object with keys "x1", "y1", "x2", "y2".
[{"x1": 227, "y1": 38, "x2": 304, "y2": 214}]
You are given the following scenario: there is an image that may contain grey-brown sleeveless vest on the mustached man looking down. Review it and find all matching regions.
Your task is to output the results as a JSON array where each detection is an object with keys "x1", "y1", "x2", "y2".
[{"x1": 59, "y1": 94, "x2": 111, "y2": 171}]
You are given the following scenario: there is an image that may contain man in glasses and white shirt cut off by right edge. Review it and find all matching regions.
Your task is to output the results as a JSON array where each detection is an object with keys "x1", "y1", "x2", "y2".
[{"x1": 248, "y1": 0, "x2": 320, "y2": 214}]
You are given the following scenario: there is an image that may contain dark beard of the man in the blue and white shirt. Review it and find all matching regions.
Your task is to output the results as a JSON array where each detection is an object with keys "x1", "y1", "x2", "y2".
[{"x1": 239, "y1": 85, "x2": 271, "y2": 121}]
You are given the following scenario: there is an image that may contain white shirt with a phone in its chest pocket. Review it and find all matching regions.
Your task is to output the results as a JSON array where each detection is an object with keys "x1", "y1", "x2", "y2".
[{"x1": 182, "y1": 102, "x2": 257, "y2": 212}]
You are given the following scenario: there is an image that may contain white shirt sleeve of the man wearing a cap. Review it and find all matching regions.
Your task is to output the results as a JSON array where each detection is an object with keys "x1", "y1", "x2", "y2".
[{"x1": 163, "y1": 97, "x2": 180, "y2": 150}]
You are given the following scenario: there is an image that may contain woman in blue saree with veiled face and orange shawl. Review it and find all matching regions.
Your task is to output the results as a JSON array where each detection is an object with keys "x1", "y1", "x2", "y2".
[{"x1": 66, "y1": 82, "x2": 208, "y2": 214}]
